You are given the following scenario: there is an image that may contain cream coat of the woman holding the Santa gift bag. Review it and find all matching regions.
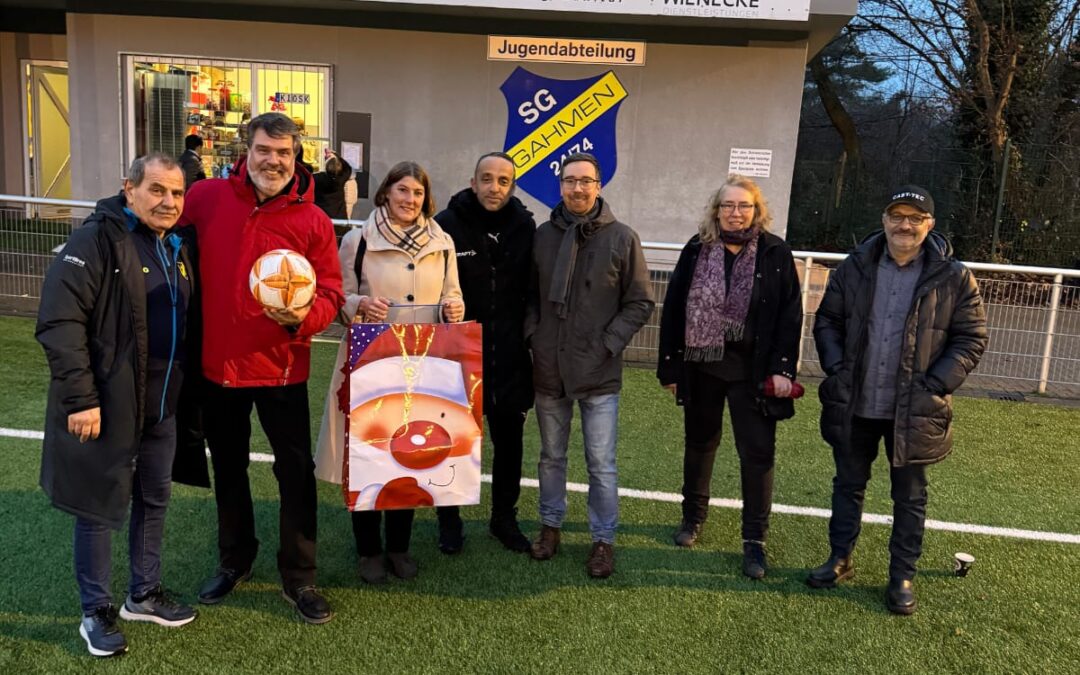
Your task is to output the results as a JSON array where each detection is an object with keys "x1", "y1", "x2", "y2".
[{"x1": 315, "y1": 212, "x2": 461, "y2": 484}]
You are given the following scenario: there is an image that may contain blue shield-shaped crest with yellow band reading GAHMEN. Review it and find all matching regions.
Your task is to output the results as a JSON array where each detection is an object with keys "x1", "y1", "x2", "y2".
[{"x1": 500, "y1": 68, "x2": 627, "y2": 208}]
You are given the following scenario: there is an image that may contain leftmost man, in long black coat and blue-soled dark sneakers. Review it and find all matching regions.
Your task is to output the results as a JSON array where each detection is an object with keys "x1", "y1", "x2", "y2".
[{"x1": 37, "y1": 153, "x2": 195, "y2": 657}]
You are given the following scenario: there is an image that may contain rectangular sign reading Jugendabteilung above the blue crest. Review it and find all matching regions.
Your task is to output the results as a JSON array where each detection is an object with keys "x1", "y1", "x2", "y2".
[{"x1": 487, "y1": 36, "x2": 645, "y2": 66}]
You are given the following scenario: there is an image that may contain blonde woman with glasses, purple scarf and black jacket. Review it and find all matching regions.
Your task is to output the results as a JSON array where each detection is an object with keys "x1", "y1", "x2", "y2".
[{"x1": 657, "y1": 175, "x2": 802, "y2": 579}]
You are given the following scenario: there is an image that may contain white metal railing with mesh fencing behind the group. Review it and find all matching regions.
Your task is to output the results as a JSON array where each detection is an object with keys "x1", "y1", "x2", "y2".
[{"x1": 0, "y1": 194, "x2": 1080, "y2": 397}]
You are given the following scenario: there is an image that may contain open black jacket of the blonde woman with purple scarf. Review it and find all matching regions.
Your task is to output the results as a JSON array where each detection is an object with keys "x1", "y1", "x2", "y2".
[{"x1": 657, "y1": 232, "x2": 802, "y2": 419}]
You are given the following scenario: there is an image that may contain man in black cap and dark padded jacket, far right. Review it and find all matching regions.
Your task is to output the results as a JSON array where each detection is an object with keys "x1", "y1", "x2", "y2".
[{"x1": 807, "y1": 186, "x2": 987, "y2": 615}]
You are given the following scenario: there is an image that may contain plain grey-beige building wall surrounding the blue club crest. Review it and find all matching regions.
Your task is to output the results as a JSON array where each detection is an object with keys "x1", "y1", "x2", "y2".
[{"x1": 68, "y1": 14, "x2": 806, "y2": 242}]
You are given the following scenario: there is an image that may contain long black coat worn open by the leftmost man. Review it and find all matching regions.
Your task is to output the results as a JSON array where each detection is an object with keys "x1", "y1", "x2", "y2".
[{"x1": 36, "y1": 195, "x2": 198, "y2": 529}]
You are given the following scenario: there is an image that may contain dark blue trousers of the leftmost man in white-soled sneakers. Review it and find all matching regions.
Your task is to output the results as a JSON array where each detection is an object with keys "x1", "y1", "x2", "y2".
[{"x1": 75, "y1": 416, "x2": 176, "y2": 613}]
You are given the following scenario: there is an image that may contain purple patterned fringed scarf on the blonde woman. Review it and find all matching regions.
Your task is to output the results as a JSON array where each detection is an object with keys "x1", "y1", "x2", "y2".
[{"x1": 684, "y1": 227, "x2": 759, "y2": 362}]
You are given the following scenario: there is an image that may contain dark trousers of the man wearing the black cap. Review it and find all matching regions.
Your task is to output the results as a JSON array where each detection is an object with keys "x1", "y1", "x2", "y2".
[{"x1": 828, "y1": 417, "x2": 927, "y2": 579}]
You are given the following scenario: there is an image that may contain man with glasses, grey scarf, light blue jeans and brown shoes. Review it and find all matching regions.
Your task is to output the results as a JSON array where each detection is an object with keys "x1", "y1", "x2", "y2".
[{"x1": 525, "y1": 152, "x2": 653, "y2": 579}]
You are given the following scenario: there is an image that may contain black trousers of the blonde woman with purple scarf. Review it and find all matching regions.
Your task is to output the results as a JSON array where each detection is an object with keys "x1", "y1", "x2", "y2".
[{"x1": 683, "y1": 370, "x2": 777, "y2": 541}]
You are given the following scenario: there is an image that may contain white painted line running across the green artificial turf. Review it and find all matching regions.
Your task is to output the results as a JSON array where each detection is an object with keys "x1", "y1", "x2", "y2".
[{"x1": 0, "y1": 427, "x2": 1080, "y2": 544}]
